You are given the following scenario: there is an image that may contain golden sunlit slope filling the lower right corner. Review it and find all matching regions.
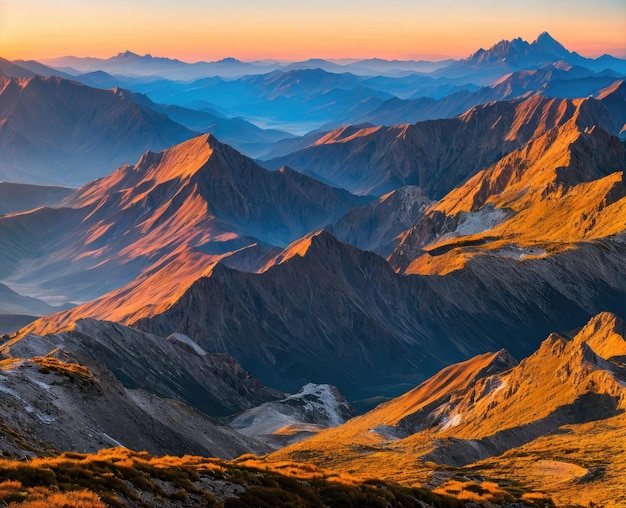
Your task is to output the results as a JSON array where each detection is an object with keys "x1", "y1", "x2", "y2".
[{"x1": 266, "y1": 313, "x2": 626, "y2": 505}]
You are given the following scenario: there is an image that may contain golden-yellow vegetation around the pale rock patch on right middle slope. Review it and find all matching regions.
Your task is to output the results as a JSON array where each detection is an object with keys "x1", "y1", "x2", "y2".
[{"x1": 406, "y1": 116, "x2": 626, "y2": 275}]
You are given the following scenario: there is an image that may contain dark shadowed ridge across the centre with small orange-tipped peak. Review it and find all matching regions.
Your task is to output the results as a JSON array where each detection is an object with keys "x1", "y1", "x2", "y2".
[{"x1": 128, "y1": 228, "x2": 626, "y2": 400}]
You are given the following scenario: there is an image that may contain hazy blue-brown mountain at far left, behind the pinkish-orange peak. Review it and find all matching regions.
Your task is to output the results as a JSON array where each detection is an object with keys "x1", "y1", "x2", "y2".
[{"x1": 0, "y1": 76, "x2": 194, "y2": 185}]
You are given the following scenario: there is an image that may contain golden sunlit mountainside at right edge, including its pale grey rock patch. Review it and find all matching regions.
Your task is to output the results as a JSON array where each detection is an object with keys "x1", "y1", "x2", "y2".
[{"x1": 390, "y1": 108, "x2": 626, "y2": 275}]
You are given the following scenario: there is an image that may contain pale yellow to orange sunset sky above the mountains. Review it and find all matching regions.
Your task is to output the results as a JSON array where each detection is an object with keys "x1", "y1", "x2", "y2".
[{"x1": 0, "y1": 0, "x2": 626, "y2": 61}]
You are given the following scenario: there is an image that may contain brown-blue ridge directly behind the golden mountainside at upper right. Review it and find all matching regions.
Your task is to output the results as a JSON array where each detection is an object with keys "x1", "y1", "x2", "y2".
[{"x1": 266, "y1": 91, "x2": 623, "y2": 198}]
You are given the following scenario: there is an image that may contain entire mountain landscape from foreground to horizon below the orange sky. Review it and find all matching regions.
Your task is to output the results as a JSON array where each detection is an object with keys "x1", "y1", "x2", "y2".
[{"x1": 0, "y1": 33, "x2": 626, "y2": 508}]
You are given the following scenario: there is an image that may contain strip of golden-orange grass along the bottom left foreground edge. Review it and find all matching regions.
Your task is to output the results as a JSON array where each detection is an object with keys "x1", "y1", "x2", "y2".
[{"x1": 0, "y1": 448, "x2": 462, "y2": 508}]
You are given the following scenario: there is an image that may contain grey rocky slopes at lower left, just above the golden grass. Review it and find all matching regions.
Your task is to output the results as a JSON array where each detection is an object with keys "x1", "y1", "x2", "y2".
[{"x1": 0, "y1": 320, "x2": 279, "y2": 458}]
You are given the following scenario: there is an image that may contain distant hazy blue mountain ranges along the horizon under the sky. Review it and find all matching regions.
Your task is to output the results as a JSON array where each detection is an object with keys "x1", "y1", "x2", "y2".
[{"x1": 56, "y1": 34, "x2": 626, "y2": 139}]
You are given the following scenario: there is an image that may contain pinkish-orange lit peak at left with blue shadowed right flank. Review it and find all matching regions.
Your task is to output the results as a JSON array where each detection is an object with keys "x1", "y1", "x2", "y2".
[{"x1": 0, "y1": 135, "x2": 368, "y2": 319}]
